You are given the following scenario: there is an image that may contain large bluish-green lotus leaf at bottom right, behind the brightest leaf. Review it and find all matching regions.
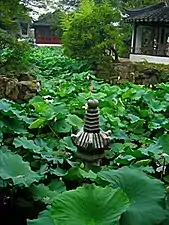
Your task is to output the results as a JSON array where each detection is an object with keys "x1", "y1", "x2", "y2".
[{"x1": 98, "y1": 167, "x2": 165, "y2": 225}]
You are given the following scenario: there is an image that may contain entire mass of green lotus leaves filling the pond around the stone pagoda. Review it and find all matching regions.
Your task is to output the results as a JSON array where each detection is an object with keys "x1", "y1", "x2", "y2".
[{"x1": 0, "y1": 48, "x2": 169, "y2": 225}]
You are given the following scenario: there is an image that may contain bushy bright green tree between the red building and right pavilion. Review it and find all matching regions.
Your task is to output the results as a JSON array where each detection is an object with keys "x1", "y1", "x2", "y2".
[{"x1": 62, "y1": 0, "x2": 123, "y2": 62}]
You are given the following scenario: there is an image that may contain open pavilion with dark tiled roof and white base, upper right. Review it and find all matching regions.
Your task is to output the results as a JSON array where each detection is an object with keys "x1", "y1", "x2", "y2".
[{"x1": 125, "y1": 0, "x2": 169, "y2": 64}]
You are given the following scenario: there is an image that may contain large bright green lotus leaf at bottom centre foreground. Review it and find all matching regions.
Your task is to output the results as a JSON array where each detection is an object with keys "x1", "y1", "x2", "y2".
[{"x1": 50, "y1": 185, "x2": 129, "y2": 225}]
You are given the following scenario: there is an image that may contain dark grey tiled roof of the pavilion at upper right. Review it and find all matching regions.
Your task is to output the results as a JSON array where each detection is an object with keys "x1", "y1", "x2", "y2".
[{"x1": 125, "y1": 2, "x2": 169, "y2": 23}]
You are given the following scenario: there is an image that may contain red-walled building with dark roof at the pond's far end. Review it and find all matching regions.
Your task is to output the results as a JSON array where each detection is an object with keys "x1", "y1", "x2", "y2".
[{"x1": 32, "y1": 15, "x2": 61, "y2": 44}]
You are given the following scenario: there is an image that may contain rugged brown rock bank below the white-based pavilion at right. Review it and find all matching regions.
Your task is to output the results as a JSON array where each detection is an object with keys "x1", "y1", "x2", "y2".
[{"x1": 97, "y1": 62, "x2": 168, "y2": 85}]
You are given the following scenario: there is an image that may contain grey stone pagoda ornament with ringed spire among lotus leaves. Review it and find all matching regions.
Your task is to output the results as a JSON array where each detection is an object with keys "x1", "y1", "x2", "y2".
[{"x1": 71, "y1": 99, "x2": 111, "y2": 163}]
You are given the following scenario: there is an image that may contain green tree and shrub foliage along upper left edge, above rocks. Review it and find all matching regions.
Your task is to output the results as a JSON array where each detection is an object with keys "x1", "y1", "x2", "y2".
[{"x1": 0, "y1": 0, "x2": 30, "y2": 75}]
